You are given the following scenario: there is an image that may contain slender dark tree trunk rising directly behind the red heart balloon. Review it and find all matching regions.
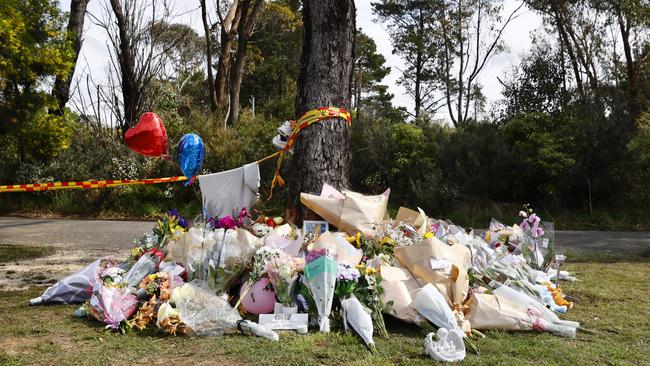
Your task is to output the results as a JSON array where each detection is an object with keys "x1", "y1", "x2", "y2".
[{"x1": 111, "y1": 0, "x2": 142, "y2": 131}]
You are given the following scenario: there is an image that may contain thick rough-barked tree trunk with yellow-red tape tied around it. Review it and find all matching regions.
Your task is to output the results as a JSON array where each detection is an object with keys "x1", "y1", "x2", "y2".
[{"x1": 288, "y1": 0, "x2": 356, "y2": 222}]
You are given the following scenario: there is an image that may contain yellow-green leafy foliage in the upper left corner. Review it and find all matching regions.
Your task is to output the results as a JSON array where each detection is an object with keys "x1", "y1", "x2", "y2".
[{"x1": 0, "y1": 0, "x2": 73, "y2": 160}]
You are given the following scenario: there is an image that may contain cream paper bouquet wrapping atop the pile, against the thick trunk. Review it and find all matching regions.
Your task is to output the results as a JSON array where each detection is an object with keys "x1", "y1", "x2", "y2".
[{"x1": 300, "y1": 185, "x2": 390, "y2": 233}]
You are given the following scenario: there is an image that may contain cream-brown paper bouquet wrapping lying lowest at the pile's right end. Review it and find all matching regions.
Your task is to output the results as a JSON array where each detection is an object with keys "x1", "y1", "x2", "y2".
[{"x1": 465, "y1": 294, "x2": 533, "y2": 330}]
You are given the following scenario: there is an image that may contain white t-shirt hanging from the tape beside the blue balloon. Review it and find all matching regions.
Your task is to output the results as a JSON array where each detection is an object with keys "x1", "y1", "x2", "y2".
[{"x1": 199, "y1": 163, "x2": 260, "y2": 217}]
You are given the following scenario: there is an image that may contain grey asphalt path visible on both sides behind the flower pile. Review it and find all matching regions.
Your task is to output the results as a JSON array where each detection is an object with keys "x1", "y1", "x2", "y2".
[{"x1": 0, "y1": 217, "x2": 650, "y2": 253}]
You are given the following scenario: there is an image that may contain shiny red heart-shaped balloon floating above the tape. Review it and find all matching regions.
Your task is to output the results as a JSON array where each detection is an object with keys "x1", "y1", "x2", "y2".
[{"x1": 124, "y1": 112, "x2": 167, "y2": 156}]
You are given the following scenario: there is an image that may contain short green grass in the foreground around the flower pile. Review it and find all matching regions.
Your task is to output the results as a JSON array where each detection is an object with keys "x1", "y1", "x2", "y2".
[{"x1": 0, "y1": 257, "x2": 650, "y2": 366}]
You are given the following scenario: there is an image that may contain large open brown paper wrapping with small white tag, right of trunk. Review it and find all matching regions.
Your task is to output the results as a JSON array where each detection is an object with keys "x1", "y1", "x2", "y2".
[{"x1": 395, "y1": 237, "x2": 471, "y2": 309}]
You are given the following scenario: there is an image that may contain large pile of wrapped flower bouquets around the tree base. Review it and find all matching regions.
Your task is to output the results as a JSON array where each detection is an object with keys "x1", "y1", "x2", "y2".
[{"x1": 31, "y1": 190, "x2": 579, "y2": 361}]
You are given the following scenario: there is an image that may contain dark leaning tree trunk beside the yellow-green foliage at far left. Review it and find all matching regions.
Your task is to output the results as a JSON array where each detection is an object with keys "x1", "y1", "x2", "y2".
[{"x1": 52, "y1": 0, "x2": 90, "y2": 116}]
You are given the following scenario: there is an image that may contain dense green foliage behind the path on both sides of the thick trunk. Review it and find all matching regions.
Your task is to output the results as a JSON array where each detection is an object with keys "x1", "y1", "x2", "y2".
[{"x1": 0, "y1": 0, "x2": 650, "y2": 227}]
